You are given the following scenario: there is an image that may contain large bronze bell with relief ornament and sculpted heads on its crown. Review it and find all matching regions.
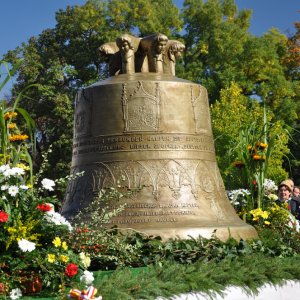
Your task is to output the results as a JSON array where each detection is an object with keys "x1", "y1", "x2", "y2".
[{"x1": 62, "y1": 34, "x2": 257, "y2": 240}]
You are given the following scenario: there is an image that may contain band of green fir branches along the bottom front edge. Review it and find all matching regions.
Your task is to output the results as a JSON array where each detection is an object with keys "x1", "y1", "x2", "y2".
[{"x1": 17, "y1": 254, "x2": 300, "y2": 300}]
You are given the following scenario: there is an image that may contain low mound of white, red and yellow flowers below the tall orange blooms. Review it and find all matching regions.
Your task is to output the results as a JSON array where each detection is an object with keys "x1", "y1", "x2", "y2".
[{"x1": 0, "y1": 164, "x2": 88, "y2": 299}]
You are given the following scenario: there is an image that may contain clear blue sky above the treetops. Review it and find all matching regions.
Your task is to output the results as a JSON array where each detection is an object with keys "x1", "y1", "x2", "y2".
[{"x1": 0, "y1": 0, "x2": 300, "y2": 96}]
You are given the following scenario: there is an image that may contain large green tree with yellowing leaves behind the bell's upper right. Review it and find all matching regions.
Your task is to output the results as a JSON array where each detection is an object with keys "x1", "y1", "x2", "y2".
[{"x1": 183, "y1": 0, "x2": 296, "y2": 113}]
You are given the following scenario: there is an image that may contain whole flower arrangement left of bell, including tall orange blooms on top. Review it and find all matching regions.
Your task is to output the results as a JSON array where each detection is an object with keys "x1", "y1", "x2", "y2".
[{"x1": 0, "y1": 66, "x2": 99, "y2": 299}]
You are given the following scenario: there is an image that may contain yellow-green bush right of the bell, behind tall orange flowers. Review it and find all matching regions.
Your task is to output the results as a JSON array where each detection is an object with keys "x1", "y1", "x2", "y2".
[{"x1": 211, "y1": 83, "x2": 289, "y2": 190}]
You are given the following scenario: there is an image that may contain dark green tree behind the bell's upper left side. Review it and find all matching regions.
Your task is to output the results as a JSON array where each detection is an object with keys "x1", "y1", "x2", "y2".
[{"x1": 5, "y1": 0, "x2": 182, "y2": 178}]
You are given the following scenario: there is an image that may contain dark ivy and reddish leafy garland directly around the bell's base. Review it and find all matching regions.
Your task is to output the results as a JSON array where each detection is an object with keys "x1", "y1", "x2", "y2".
[{"x1": 69, "y1": 217, "x2": 300, "y2": 270}]
